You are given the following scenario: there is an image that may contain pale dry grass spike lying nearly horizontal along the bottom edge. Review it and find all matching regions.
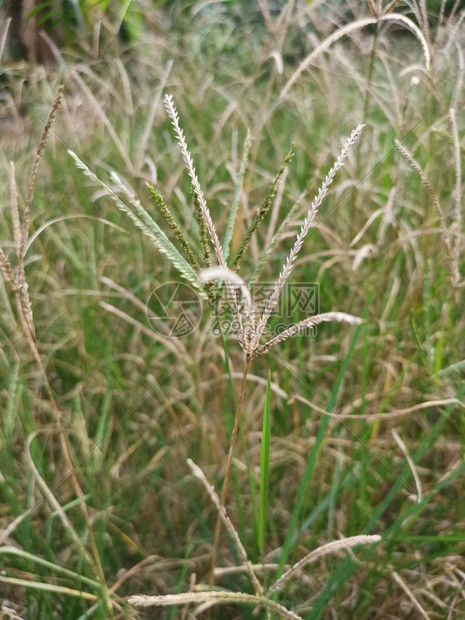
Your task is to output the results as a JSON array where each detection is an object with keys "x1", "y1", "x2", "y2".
[{"x1": 128, "y1": 590, "x2": 303, "y2": 620}]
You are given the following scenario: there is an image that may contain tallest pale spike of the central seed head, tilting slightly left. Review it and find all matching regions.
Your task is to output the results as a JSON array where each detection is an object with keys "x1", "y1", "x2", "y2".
[{"x1": 163, "y1": 95, "x2": 227, "y2": 268}]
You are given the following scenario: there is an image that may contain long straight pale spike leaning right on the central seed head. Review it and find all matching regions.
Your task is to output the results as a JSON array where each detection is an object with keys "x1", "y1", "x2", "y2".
[{"x1": 252, "y1": 125, "x2": 363, "y2": 350}]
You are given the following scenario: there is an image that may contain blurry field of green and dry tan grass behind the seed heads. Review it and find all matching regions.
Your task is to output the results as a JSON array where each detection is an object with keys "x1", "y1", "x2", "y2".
[{"x1": 0, "y1": 2, "x2": 465, "y2": 620}]
